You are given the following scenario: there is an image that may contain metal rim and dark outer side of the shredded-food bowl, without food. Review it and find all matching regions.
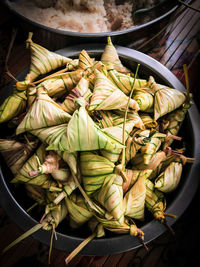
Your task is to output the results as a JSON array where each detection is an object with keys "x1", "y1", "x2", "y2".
[{"x1": 0, "y1": 0, "x2": 180, "y2": 50}]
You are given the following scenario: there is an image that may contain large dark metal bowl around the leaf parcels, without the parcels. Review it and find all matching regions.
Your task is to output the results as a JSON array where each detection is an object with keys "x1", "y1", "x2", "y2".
[{"x1": 0, "y1": 44, "x2": 200, "y2": 255}]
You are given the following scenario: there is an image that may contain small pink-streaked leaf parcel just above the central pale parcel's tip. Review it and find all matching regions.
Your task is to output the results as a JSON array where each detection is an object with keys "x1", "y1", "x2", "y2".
[{"x1": 61, "y1": 78, "x2": 92, "y2": 114}]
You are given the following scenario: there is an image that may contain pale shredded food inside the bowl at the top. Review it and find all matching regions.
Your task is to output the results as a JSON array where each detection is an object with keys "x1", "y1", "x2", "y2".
[{"x1": 7, "y1": 0, "x2": 161, "y2": 33}]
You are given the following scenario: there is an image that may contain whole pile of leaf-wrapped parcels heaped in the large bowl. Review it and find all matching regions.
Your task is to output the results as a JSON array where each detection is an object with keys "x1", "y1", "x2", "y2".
[{"x1": 0, "y1": 33, "x2": 193, "y2": 262}]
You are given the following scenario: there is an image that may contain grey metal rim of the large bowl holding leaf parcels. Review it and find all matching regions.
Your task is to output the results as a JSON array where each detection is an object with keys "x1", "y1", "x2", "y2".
[{"x1": 0, "y1": 44, "x2": 200, "y2": 256}]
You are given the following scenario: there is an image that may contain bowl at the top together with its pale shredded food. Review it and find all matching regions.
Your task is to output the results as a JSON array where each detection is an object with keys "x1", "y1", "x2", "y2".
[{"x1": 4, "y1": 0, "x2": 177, "y2": 49}]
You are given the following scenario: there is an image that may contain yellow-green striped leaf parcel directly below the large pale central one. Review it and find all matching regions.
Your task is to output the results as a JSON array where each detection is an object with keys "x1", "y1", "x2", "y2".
[{"x1": 80, "y1": 152, "x2": 115, "y2": 195}]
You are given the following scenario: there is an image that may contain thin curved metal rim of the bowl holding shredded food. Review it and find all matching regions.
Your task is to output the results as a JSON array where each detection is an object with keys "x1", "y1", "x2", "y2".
[{"x1": 0, "y1": 0, "x2": 180, "y2": 38}]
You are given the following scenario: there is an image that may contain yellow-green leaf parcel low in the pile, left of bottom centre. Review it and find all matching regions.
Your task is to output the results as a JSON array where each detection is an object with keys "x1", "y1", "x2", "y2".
[{"x1": 65, "y1": 194, "x2": 93, "y2": 229}]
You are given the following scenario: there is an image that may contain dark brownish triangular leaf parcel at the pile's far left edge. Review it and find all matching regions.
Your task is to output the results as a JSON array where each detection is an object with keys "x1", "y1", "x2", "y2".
[{"x1": 0, "y1": 138, "x2": 38, "y2": 175}]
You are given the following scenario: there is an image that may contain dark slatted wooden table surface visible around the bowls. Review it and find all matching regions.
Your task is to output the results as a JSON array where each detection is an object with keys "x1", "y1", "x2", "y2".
[{"x1": 0, "y1": 0, "x2": 200, "y2": 267}]
